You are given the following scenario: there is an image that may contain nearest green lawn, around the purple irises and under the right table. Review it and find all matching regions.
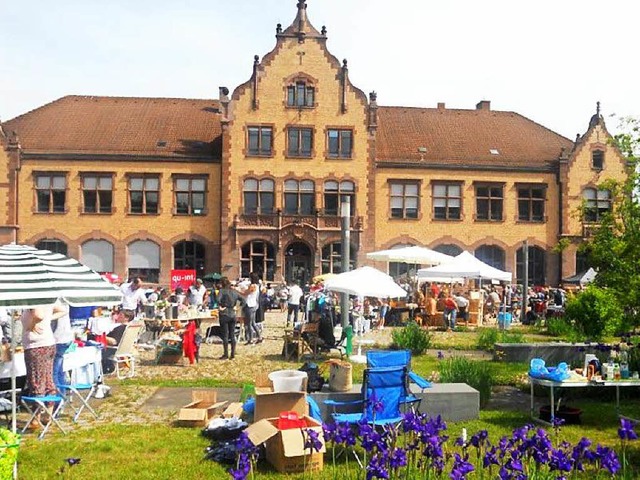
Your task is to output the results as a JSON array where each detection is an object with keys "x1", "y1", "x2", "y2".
[{"x1": 19, "y1": 399, "x2": 640, "y2": 480}]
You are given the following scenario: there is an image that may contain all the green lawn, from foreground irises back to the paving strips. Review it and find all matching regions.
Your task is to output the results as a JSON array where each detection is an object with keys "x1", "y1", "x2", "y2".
[{"x1": 19, "y1": 331, "x2": 640, "y2": 480}]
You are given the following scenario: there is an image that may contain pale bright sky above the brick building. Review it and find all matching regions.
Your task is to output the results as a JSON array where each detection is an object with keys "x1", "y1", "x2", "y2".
[{"x1": 0, "y1": 0, "x2": 640, "y2": 139}]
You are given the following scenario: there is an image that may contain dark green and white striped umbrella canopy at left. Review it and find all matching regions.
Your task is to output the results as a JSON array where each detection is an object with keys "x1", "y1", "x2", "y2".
[{"x1": 0, "y1": 244, "x2": 122, "y2": 308}]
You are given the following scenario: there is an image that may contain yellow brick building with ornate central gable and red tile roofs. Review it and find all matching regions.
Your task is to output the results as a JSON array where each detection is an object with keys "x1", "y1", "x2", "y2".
[{"x1": 0, "y1": 0, "x2": 626, "y2": 283}]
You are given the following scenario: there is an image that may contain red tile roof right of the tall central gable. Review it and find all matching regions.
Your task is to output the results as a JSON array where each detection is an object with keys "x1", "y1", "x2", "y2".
[{"x1": 376, "y1": 107, "x2": 573, "y2": 167}]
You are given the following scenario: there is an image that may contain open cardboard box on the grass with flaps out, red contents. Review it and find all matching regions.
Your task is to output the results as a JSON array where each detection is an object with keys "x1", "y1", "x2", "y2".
[{"x1": 245, "y1": 415, "x2": 326, "y2": 473}]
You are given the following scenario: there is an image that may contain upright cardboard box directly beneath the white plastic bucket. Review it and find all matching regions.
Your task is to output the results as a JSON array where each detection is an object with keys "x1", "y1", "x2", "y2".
[{"x1": 253, "y1": 374, "x2": 309, "y2": 422}]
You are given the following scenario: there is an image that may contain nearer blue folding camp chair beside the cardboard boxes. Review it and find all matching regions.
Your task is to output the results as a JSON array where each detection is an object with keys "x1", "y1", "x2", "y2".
[{"x1": 324, "y1": 367, "x2": 407, "y2": 426}]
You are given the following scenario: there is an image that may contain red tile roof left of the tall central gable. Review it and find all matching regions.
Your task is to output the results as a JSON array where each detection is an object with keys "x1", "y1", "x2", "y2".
[{"x1": 3, "y1": 96, "x2": 222, "y2": 159}]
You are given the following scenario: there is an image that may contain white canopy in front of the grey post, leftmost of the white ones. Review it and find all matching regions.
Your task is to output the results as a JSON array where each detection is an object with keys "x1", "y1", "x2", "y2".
[{"x1": 324, "y1": 267, "x2": 407, "y2": 298}]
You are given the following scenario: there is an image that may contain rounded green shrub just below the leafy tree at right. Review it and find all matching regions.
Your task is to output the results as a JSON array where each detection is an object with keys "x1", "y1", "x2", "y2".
[{"x1": 565, "y1": 285, "x2": 624, "y2": 340}]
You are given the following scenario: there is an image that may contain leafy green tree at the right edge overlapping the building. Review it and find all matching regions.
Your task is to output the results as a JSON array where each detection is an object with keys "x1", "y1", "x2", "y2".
[{"x1": 581, "y1": 118, "x2": 640, "y2": 326}]
